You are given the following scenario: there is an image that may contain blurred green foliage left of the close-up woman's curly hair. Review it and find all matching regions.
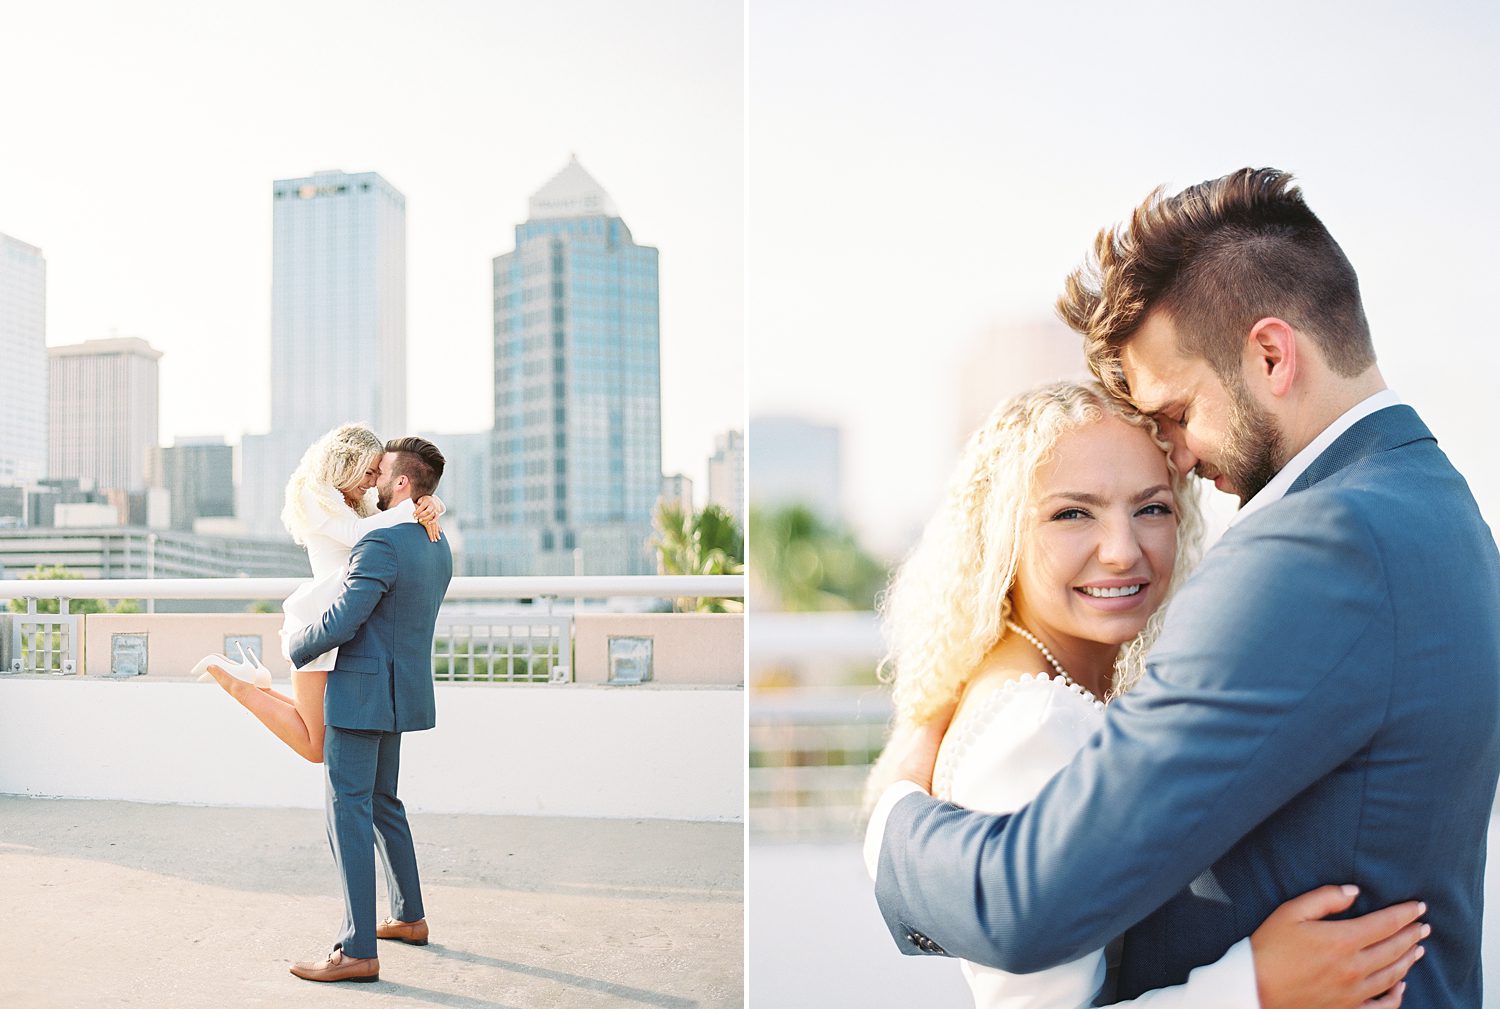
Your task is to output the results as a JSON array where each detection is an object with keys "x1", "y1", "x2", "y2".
[{"x1": 750, "y1": 504, "x2": 890, "y2": 612}]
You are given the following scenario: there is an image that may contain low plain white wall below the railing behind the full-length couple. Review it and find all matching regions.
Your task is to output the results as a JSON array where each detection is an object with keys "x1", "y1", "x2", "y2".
[{"x1": 0, "y1": 676, "x2": 746, "y2": 822}]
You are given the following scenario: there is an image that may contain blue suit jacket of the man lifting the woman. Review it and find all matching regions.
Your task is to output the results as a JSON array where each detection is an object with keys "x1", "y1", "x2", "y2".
[{"x1": 290, "y1": 522, "x2": 453, "y2": 732}]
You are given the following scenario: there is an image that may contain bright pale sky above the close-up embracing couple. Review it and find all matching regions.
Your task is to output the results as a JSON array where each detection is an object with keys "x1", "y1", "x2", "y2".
[{"x1": 749, "y1": 0, "x2": 1500, "y2": 552}]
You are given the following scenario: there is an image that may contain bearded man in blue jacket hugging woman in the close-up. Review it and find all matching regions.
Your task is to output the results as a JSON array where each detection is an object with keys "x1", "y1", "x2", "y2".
[{"x1": 867, "y1": 168, "x2": 1500, "y2": 1009}]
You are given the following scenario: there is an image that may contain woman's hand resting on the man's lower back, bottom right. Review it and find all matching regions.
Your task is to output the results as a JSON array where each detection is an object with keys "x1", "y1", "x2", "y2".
[{"x1": 1250, "y1": 886, "x2": 1433, "y2": 1009}]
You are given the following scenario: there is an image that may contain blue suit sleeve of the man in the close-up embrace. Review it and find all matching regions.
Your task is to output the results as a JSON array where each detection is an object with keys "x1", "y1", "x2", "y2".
[{"x1": 876, "y1": 492, "x2": 1392, "y2": 973}]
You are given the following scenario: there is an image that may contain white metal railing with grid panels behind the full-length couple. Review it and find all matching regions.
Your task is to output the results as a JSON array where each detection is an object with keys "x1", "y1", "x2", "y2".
[{"x1": 0, "y1": 574, "x2": 746, "y2": 684}]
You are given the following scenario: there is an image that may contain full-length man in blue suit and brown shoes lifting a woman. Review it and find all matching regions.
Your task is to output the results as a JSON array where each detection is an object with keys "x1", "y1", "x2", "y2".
[{"x1": 290, "y1": 438, "x2": 453, "y2": 981}]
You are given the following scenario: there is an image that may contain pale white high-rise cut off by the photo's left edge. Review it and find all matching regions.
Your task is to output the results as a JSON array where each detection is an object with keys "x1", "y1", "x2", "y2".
[{"x1": 0, "y1": 235, "x2": 48, "y2": 486}]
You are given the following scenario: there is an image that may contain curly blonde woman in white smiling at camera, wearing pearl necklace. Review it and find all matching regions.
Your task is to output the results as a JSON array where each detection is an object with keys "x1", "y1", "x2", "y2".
[{"x1": 872, "y1": 382, "x2": 1425, "y2": 1009}]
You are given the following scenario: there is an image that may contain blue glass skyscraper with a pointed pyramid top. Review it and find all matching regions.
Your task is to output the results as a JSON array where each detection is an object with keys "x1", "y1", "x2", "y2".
[{"x1": 492, "y1": 157, "x2": 662, "y2": 574}]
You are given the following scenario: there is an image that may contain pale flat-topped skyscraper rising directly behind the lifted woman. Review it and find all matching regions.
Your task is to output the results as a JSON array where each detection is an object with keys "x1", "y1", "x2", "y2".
[{"x1": 240, "y1": 171, "x2": 407, "y2": 535}]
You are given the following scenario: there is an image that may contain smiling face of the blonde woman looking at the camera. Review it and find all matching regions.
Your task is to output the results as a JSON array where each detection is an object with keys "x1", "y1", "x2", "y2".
[{"x1": 1011, "y1": 417, "x2": 1178, "y2": 645}]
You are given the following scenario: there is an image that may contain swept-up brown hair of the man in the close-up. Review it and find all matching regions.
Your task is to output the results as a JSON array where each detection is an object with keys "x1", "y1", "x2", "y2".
[{"x1": 1058, "y1": 168, "x2": 1376, "y2": 399}]
